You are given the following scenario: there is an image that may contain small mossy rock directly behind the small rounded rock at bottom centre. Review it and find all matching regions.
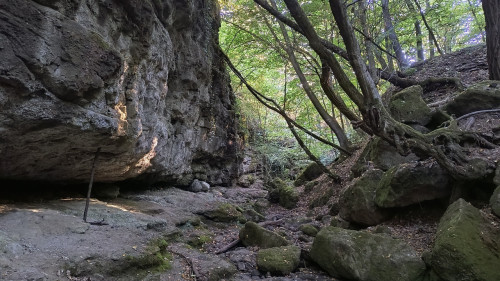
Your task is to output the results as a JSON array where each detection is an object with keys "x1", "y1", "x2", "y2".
[{"x1": 240, "y1": 222, "x2": 289, "y2": 249}]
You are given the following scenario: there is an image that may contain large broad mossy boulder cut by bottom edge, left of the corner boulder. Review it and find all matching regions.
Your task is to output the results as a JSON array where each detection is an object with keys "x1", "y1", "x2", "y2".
[{"x1": 310, "y1": 226, "x2": 425, "y2": 281}]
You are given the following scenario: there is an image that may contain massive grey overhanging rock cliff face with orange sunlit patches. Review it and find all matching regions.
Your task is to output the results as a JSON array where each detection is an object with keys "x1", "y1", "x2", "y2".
[{"x1": 0, "y1": 0, "x2": 236, "y2": 184}]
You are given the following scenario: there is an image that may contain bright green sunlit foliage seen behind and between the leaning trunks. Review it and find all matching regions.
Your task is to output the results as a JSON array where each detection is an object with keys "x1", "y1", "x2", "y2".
[{"x1": 219, "y1": 0, "x2": 484, "y2": 159}]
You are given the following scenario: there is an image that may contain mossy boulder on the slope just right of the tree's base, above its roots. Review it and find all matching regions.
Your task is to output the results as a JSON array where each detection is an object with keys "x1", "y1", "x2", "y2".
[{"x1": 389, "y1": 85, "x2": 431, "y2": 126}]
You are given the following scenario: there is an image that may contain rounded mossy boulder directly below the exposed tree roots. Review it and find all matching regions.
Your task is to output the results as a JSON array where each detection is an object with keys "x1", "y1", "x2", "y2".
[{"x1": 375, "y1": 161, "x2": 451, "y2": 208}]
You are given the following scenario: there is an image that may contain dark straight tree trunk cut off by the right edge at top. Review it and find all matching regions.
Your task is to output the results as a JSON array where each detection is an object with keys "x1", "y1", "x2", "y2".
[{"x1": 483, "y1": 0, "x2": 500, "y2": 80}]
